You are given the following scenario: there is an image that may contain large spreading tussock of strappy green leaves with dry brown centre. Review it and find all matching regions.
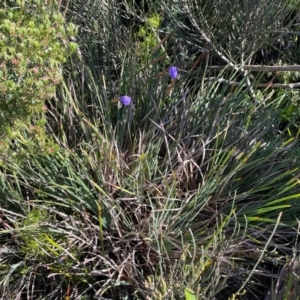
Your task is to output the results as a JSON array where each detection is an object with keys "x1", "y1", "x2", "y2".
[{"x1": 2, "y1": 55, "x2": 298, "y2": 298}]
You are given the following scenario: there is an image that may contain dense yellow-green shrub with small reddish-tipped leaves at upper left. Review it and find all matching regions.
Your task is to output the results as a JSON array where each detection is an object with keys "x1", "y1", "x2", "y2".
[{"x1": 0, "y1": 0, "x2": 76, "y2": 146}]
